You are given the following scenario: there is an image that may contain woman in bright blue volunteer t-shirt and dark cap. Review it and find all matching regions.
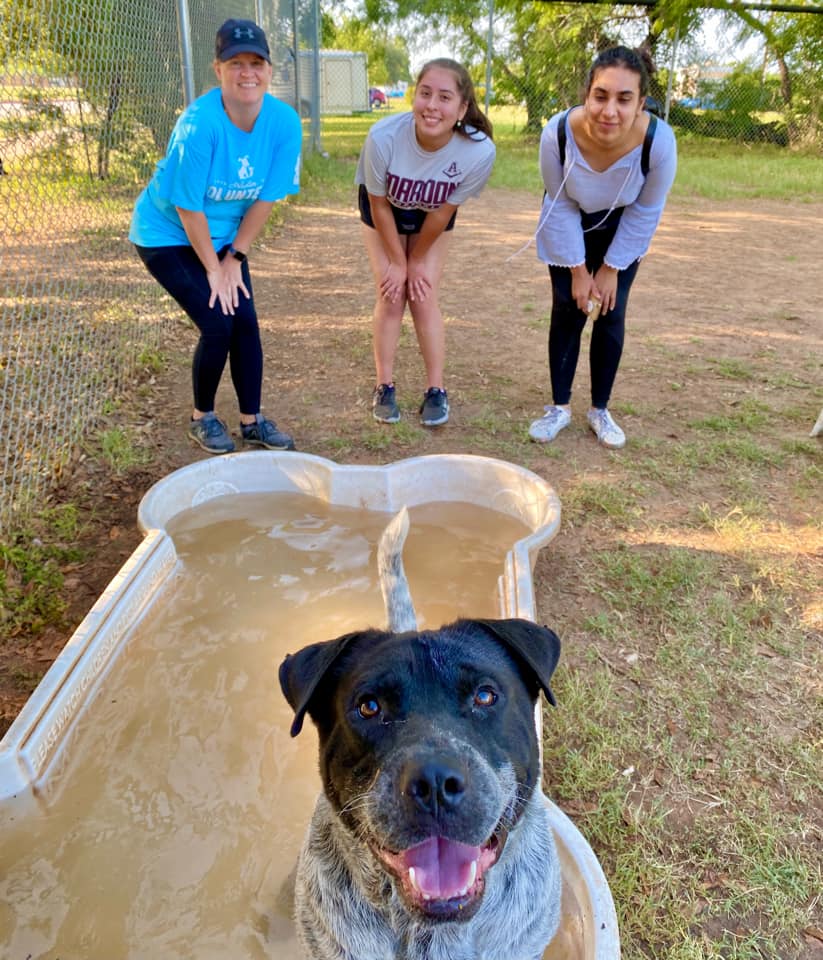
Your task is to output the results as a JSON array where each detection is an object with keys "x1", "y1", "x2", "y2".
[{"x1": 129, "y1": 19, "x2": 302, "y2": 453}]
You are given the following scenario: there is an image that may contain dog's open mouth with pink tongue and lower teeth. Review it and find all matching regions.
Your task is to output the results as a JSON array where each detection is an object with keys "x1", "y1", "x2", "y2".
[{"x1": 377, "y1": 830, "x2": 506, "y2": 920}]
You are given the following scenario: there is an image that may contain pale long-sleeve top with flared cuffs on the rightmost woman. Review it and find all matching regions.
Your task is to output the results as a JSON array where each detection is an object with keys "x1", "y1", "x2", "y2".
[{"x1": 537, "y1": 111, "x2": 677, "y2": 270}]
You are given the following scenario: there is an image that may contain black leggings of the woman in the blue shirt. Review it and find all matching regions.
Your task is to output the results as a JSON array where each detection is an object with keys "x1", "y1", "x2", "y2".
[{"x1": 136, "y1": 247, "x2": 263, "y2": 414}]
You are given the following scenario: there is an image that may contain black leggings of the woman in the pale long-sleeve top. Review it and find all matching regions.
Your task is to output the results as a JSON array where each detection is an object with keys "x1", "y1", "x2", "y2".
[{"x1": 549, "y1": 208, "x2": 640, "y2": 409}]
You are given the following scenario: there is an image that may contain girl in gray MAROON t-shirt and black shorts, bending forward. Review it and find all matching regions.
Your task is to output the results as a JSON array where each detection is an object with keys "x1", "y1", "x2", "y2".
[{"x1": 355, "y1": 58, "x2": 495, "y2": 427}]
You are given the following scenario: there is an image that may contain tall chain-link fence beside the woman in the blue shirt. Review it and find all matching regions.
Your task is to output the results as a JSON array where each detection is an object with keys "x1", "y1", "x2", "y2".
[{"x1": 0, "y1": 0, "x2": 316, "y2": 533}]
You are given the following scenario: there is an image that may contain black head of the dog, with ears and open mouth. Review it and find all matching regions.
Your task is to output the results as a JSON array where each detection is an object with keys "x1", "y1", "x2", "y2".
[{"x1": 280, "y1": 620, "x2": 559, "y2": 920}]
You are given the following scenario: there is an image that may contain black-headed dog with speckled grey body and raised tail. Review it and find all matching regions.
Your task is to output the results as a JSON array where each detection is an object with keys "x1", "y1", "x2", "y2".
[{"x1": 280, "y1": 509, "x2": 561, "y2": 960}]
